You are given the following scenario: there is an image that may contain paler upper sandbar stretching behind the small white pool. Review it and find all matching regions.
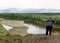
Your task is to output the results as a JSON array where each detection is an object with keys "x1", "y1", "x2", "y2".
[{"x1": 1, "y1": 20, "x2": 25, "y2": 27}]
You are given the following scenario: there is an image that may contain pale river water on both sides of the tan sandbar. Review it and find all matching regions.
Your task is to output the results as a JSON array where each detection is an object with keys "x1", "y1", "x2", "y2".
[{"x1": 2, "y1": 24, "x2": 46, "y2": 34}]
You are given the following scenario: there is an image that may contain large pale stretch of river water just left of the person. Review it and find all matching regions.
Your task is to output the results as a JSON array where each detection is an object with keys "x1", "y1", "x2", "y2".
[{"x1": 25, "y1": 24, "x2": 46, "y2": 34}]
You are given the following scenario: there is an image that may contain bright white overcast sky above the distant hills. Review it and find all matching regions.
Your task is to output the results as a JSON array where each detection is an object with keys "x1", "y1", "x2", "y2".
[{"x1": 0, "y1": 0, "x2": 60, "y2": 9}]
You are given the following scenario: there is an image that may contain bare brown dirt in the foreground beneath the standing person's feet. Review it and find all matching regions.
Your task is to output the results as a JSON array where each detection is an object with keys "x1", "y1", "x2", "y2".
[{"x1": 24, "y1": 35, "x2": 60, "y2": 43}]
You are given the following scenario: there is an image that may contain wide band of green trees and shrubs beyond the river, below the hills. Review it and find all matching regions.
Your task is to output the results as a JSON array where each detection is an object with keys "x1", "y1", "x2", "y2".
[{"x1": 0, "y1": 13, "x2": 60, "y2": 26}]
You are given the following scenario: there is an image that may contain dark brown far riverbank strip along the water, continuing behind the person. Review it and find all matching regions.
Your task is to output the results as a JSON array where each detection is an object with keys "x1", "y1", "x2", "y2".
[{"x1": 25, "y1": 21, "x2": 60, "y2": 32}]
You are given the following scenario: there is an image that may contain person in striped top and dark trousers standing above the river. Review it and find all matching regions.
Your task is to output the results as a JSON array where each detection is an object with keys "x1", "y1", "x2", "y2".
[{"x1": 46, "y1": 17, "x2": 55, "y2": 35}]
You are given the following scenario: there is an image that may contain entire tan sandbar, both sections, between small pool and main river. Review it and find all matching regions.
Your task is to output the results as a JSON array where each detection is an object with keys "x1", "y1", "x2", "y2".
[{"x1": 1, "y1": 20, "x2": 28, "y2": 36}]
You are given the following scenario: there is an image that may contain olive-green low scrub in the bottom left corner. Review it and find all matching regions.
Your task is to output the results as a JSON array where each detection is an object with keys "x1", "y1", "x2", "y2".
[{"x1": 0, "y1": 35, "x2": 23, "y2": 43}]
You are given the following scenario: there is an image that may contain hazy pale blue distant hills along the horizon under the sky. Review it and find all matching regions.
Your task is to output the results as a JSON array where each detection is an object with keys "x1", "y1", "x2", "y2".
[{"x1": 0, "y1": 8, "x2": 60, "y2": 13}]
